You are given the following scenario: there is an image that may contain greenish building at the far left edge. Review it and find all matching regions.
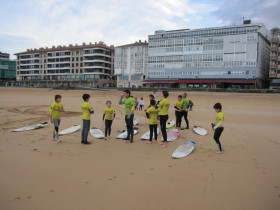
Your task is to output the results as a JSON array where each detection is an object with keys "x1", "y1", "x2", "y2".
[{"x1": 0, "y1": 52, "x2": 16, "y2": 80}]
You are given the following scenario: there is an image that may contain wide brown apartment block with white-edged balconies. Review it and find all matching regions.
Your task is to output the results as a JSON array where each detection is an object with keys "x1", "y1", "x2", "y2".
[{"x1": 15, "y1": 42, "x2": 114, "y2": 86}]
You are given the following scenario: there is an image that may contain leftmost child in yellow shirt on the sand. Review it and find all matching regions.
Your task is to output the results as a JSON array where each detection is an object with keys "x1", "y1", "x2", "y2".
[{"x1": 49, "y1": 95, "x2": 64, "y2": 143}]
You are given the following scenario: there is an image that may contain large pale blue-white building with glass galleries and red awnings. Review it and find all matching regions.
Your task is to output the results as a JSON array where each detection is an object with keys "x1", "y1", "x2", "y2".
[{"x1": 145, "y1": 21, "x2": 270, "y2": 88}]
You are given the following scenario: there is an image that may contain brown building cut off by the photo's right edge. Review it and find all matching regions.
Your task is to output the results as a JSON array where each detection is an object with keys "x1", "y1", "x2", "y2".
[{"x1": 269, "y1": 28, "x2": 280, "y2": 89}]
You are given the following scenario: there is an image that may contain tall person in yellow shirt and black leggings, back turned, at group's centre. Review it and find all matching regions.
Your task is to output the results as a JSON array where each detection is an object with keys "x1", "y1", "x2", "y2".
[{"x1": 156, "y1": 90, "x2": 169, "y2": 147}]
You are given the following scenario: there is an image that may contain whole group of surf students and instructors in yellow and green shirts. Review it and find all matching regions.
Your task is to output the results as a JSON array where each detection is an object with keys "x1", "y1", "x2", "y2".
[{"x1": 49, "y1": 90, "x2": 224, "y2": 154}]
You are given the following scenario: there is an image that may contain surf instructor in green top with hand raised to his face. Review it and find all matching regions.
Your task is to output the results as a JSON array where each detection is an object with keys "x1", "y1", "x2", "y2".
[{"x1": 119, "y1": 90, "x2": 135, "y2": 143}]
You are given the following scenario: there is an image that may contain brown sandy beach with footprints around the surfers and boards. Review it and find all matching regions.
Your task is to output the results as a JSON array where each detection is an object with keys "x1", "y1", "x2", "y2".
[{"x1": 0, "y1": 88, "x2": 280, "y2": 210}]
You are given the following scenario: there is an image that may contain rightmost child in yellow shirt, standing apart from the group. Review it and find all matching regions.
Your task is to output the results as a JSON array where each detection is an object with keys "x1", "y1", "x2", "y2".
[{"x1": 212, "y1": 103, "x2": 224, "y2": 154}]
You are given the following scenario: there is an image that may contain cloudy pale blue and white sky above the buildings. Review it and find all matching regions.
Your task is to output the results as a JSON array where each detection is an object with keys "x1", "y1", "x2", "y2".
[{"x1": 0, "y1": 0, "x2": 280, "y2": 58}]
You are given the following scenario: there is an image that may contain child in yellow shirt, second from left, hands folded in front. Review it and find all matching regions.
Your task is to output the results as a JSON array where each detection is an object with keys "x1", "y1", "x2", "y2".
[{"x1": 81, "y1": 94, "x2": 94, "y2": 144}]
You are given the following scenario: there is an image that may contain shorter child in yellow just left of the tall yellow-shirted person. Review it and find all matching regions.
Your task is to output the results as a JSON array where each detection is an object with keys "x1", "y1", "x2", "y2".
[{"x1": 146, "y1": 99, "x2": 159, "y2": 144}]
